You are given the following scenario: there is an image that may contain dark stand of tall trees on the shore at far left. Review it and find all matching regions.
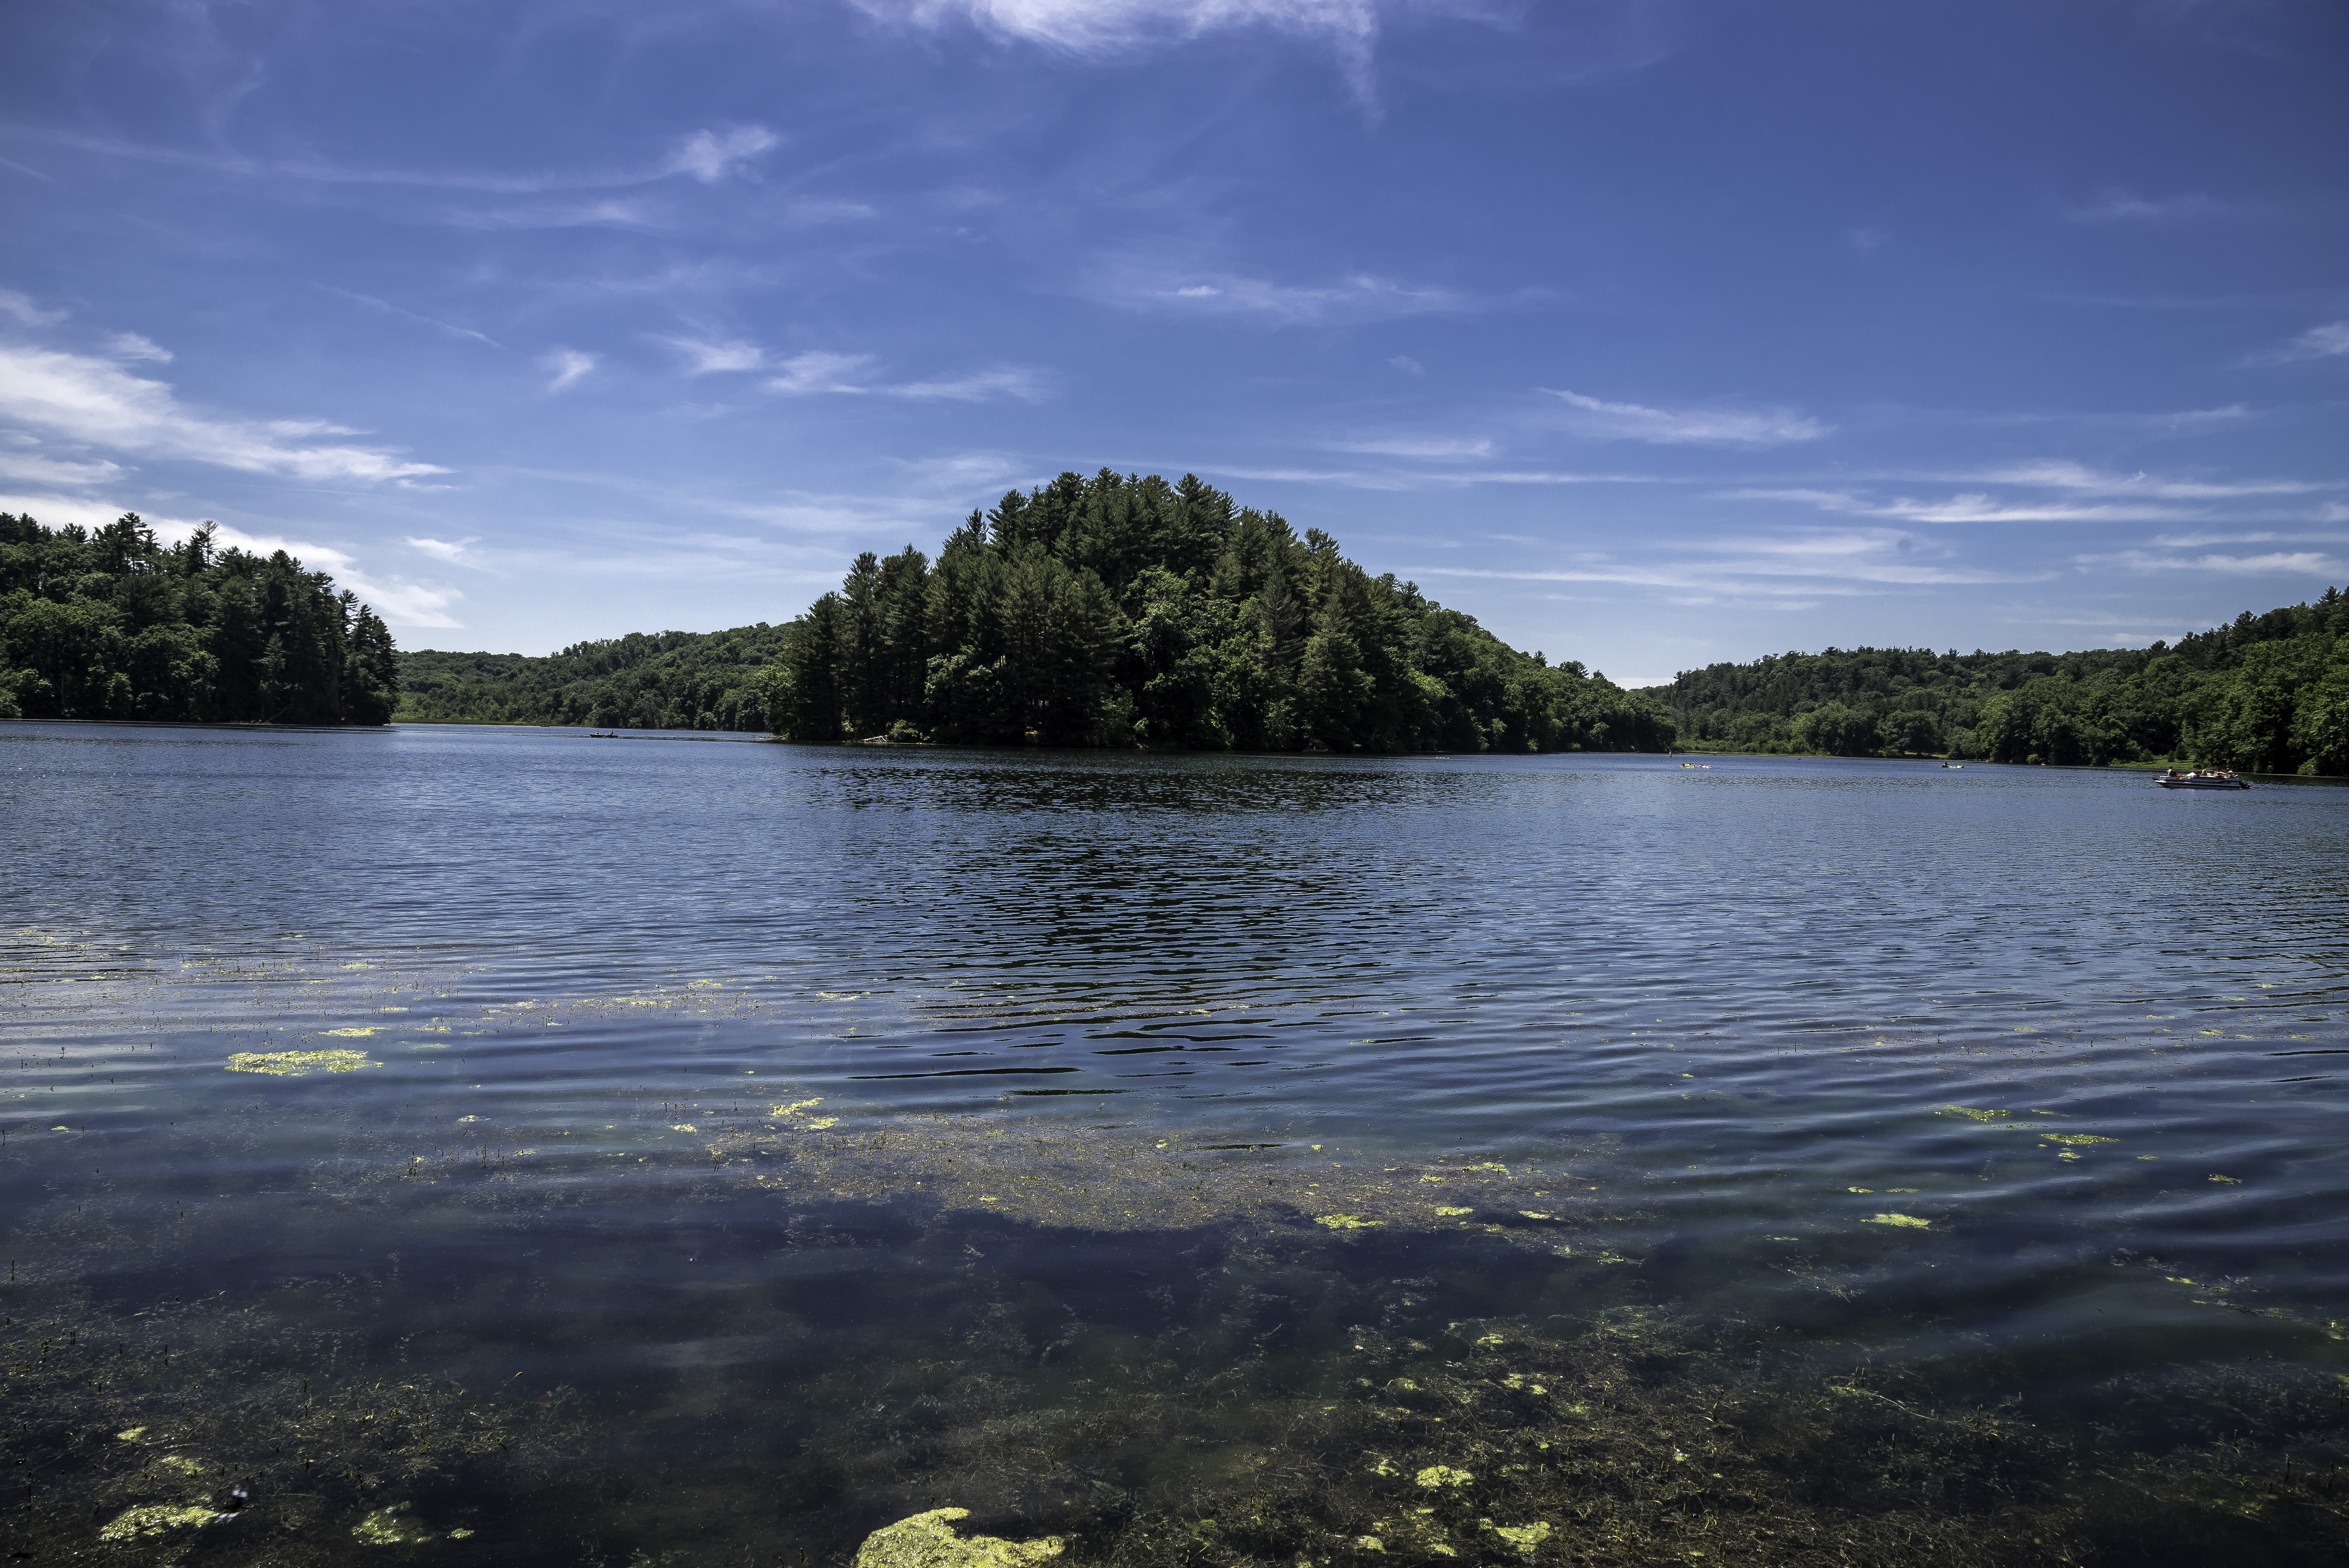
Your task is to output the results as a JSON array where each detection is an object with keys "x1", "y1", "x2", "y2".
[{"x1": 0, "y1": 512, "x2": 399, "y2": 725}]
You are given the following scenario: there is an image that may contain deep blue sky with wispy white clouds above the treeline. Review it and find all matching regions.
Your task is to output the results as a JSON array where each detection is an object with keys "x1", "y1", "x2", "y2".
[{"x1": 0, "y1": 0, "x2": 2349, "y2": 681}]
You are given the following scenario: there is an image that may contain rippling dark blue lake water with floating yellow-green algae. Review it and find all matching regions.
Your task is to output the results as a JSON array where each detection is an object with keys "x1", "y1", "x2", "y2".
[{"x1": 0, "y1": 723, "x2": 2349, "y2": 1568}]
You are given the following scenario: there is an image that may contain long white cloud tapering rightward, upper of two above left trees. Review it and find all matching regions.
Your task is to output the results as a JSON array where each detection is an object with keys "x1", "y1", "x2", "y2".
[{"x1": 0, "y1": 345, "x2": 449, "y2": 479}]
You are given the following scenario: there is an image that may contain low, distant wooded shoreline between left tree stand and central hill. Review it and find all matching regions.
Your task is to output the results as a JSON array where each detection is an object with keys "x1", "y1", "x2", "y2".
[{"x1": 395, "y1": 622, "x2": 787, "y2": 730}]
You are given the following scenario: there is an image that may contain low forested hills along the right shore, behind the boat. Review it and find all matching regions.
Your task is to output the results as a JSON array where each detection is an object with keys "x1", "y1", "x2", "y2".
[{"x1": 1651, "y1": 589, "x2": 2349, "y2": 775}]
